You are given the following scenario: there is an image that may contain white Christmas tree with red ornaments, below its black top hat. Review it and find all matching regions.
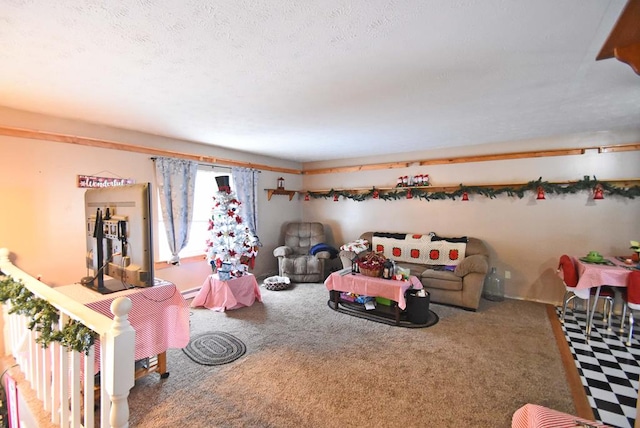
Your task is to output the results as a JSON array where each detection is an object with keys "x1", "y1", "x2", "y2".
[{"x1": 207, "y1": 189, "x2": 257, "y2": 270}]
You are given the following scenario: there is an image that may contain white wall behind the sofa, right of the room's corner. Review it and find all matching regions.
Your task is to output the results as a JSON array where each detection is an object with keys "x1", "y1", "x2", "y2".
[{"x1": 303, "y1": 135, "x2": 640, "y2": 303}]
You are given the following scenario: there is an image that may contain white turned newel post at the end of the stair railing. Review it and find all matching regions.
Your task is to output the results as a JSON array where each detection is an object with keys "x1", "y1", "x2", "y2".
[{"x1": 105, "y1": 297, "x2": 136, "y2": 428}]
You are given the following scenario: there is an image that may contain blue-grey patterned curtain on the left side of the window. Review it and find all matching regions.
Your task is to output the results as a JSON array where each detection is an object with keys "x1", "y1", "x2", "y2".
[{"x1": 155, "y1": 158, "x2": 198, "y2": 265}]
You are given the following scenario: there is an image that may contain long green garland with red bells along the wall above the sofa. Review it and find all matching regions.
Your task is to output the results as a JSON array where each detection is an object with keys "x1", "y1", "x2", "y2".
[{"x1": 307, "y1": 177, "x2": 640, "y2": 202}]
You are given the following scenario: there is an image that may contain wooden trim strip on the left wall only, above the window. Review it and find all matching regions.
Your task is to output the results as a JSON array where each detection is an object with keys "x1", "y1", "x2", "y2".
[{"x1": 0, "y1": 126, "x2": 302, "y2": 174}]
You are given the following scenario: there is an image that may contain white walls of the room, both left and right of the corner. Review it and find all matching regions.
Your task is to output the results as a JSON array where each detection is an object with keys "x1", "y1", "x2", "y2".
[{"x1": 0, "y1": 108, "x2": 640, "y2": 303}]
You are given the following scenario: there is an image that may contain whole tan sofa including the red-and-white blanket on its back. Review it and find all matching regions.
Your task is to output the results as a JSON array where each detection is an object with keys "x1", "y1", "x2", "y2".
[{"x1": 340, "y1": 232, "x2": 489, "y2": 310}]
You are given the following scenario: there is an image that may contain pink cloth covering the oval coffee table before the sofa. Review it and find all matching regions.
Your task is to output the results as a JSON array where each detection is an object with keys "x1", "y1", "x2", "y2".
[{"x1": 324, "y1": 272, "x2": 422, "y2": 309}]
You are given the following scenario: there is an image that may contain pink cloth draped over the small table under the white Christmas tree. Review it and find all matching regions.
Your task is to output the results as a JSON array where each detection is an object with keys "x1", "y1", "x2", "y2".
[{"x1": 191, "y1": 274, "x2": 262, "y2": 312}]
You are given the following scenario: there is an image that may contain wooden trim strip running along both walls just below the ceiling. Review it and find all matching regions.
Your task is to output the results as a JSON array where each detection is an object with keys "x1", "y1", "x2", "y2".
[{"x1": 0, "y1": 126, "x2": 640, "y2": 175}]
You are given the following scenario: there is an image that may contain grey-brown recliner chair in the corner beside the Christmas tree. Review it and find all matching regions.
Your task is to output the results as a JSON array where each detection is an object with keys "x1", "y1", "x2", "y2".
[{"x1": 273, "y1": 223, "x2": 331, "y2": 282}]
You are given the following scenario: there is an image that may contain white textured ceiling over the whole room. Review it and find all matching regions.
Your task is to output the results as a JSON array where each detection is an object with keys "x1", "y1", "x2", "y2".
[{"x1": 0, "y1": 0, "x2": 640, "y2": 162}]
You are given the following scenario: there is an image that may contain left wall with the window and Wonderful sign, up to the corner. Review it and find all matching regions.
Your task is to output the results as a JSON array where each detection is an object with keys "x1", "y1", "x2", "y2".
[{"x1": 0, "y1": 109, "x2": 302, "y2": 286}]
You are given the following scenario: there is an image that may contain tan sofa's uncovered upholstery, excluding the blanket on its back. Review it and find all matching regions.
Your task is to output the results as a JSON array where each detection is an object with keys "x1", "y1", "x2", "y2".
[{"x1": 340, "y1": 232, "x2": 489, "y2": 311}]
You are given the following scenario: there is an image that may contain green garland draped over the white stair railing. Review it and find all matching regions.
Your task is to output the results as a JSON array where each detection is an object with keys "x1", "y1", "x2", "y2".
[{"x1": 0, "y1": 276, "x2": 97, "y2": 355}]
